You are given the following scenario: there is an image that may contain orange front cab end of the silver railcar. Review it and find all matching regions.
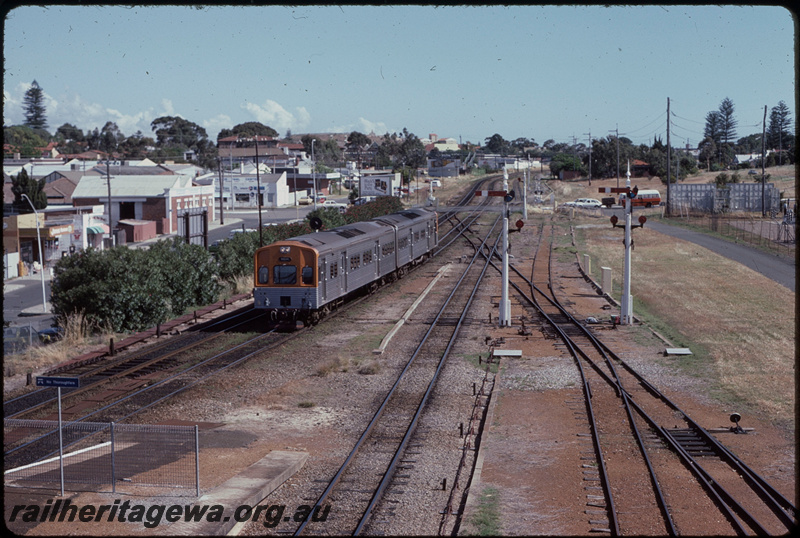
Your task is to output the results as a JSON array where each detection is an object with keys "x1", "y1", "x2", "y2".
[{"x1": 253, "y1": 241, "x2": 319, "y2": 321}]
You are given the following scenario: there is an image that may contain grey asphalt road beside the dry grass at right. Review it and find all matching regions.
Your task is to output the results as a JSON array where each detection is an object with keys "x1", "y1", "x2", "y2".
[{"x1": 647, "y1": 221, "x2": 796, "y2": 291}]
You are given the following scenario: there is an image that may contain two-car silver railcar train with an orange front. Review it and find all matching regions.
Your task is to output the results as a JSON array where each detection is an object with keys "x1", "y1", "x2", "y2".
[{"x1": 253, "y1": 208, "x2": 438, "y2": 323}]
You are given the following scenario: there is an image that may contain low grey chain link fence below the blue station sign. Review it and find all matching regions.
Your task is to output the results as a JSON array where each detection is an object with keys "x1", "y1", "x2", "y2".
[{"x1": 3, "y1": 419, "x2": 200, "y2": 496}]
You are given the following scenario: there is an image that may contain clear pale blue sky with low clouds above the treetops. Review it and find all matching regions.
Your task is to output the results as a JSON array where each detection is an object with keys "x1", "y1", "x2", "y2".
[{"x1": 3, "y1": 5, "x2": 796, "y2": 146}]
